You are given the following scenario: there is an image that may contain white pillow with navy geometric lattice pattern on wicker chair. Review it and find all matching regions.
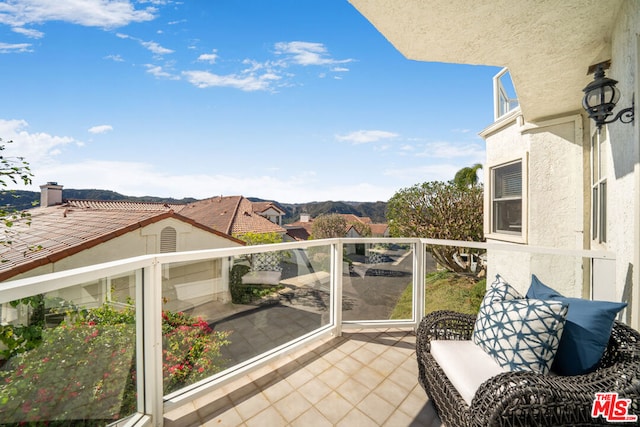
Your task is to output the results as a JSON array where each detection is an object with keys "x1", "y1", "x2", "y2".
[{"x1": 474, "y1": 299, "x2": 567, "y2": 374}]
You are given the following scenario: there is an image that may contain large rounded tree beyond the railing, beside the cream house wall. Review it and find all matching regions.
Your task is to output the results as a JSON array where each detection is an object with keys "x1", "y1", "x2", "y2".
[{"x1": 387, "y1": 181, "x2": 484, "y2": 272}]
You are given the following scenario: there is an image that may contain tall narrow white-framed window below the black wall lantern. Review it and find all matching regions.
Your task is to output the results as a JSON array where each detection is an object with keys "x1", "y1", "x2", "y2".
[{"x1": 591, "y1": 129, "x2": 607, "y2": 243}]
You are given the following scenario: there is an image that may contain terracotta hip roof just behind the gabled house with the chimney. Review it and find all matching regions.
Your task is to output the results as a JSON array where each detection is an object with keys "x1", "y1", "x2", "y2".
[{"x1": 180, "y1": 196, "x2": 285, "y2": 235}]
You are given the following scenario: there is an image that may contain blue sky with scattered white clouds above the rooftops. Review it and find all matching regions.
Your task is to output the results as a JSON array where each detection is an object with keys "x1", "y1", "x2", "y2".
[{"x1": 0, "y1": 0, "x2": 499, "y2": 203}]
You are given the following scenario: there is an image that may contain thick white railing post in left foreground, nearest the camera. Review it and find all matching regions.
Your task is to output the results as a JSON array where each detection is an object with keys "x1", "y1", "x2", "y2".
[{"x1": 142, "y1": 260, "x2": 164, "y2": 427}]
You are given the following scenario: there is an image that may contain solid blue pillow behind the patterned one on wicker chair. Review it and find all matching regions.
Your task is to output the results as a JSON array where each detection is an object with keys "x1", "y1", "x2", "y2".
[{"x1": 527, "y1": 275, "x2": 627, "y2": 375}]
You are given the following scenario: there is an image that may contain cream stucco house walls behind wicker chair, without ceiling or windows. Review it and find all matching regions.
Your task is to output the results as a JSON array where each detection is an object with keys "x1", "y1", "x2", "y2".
[{"x1": 481, "y1": 2, "x2": 640, "y2": 328}]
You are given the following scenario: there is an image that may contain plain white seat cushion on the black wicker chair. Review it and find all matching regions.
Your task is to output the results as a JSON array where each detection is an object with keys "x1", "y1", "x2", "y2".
[{"x1": 431, "y1": 340, "x2": 509, "y2": 406}]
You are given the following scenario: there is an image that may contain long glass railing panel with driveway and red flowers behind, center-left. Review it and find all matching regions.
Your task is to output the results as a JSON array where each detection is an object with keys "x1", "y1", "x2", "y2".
[{"x1": 162, "y1": 246, "x2": 331, "y2": 394}]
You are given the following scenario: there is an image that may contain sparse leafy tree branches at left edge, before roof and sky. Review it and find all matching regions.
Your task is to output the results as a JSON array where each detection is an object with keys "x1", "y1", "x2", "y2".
[{"x1": 0, "y1": 138, "x2": 33, "y2": 246}]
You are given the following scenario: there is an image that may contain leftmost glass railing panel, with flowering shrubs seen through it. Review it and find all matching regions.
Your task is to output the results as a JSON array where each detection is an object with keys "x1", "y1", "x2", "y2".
[{"x1": 0, "y1": 272, "x2": 141, "y2": 426}]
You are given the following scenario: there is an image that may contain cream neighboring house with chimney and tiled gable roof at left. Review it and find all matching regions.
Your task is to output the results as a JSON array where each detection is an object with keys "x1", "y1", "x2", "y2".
[{"x1": 0, "y1": 183, "x2": 244, "y2": 320}]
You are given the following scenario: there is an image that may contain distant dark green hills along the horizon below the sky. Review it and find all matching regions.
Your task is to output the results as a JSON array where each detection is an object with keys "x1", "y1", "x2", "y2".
[{"x1": 0, "y1": 188, "x2": 387, "y2": 223}]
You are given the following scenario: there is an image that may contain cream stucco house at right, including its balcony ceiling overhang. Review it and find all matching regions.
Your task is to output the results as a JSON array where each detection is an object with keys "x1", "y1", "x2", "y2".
[{"x1": 350, "y1": 0, "x2": 640, "y2": 329}]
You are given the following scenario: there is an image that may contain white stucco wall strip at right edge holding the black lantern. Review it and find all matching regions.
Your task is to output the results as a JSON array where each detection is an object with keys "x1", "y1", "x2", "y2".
[{"x1": 605, "y1": 1, "x2": 640, "y2": 328}]
